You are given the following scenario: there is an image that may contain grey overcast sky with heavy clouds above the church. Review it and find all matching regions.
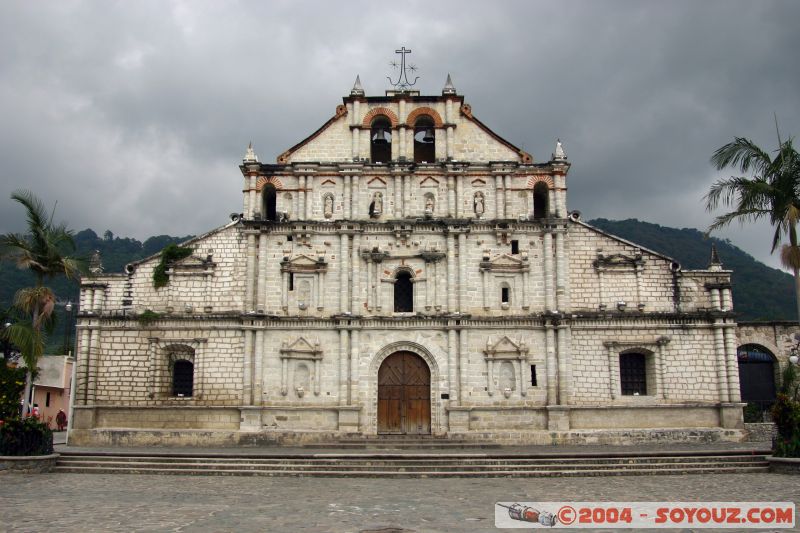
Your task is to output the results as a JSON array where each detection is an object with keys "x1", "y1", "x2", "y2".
[{"x1": 0, "y1": 0, "x2": 800, "y2": 265}]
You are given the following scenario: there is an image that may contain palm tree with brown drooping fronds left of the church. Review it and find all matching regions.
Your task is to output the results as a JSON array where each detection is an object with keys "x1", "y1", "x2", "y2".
[{"x1": 0, "y1": 191, "x2": 81, "y2": 413}]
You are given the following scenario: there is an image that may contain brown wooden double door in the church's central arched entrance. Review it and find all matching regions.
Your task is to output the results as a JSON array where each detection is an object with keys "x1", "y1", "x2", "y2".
[{"x1": 378, "y1": 352, "x2": 431, "y2": 435}]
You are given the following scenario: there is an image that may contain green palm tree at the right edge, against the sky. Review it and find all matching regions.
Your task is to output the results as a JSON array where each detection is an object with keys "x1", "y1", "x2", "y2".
[{"x1": 705, "y1": 134, "x2": 800, "y2": 319}]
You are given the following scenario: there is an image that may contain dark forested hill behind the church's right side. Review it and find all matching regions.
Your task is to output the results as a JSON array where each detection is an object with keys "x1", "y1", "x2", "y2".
[{"x1": 588, "y1": 218, "x2": 797, "y2": 321}]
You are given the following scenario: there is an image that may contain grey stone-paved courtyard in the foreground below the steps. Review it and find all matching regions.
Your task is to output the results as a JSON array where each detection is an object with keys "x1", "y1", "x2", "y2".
[{"x1": 0, "y1": 474, "x2": 800, "y2": 533}]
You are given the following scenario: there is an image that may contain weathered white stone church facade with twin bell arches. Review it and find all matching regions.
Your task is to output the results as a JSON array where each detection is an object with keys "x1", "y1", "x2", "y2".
[{"x1": 70, "y1": 78, "x2": 742, "y2": 445}]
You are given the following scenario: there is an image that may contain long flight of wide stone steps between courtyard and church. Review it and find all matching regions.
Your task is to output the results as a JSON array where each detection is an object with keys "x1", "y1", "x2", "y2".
[{"x1": 55, "y1": 452, "x2": 769, "y2": 477}]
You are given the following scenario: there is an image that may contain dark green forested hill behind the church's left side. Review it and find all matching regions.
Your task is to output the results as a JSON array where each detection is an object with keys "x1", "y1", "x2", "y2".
[{"x1": 0, "y1": 229, "x2": 192, "y2": 309}]
